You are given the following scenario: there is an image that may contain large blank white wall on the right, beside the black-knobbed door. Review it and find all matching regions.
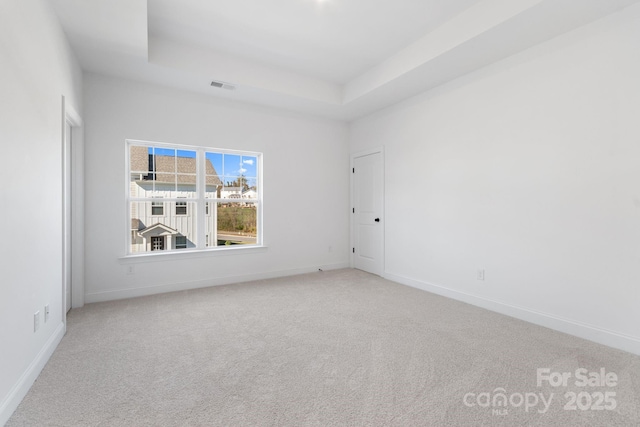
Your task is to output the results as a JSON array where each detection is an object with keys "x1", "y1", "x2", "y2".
[{"x1": 350, "y1": 6, "x2": 640, "y2": 353}]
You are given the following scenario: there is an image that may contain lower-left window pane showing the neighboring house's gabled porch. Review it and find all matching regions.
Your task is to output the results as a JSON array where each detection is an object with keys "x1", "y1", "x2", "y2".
[{"x1": 130, "y1": 201, "x2": 197, "y2": 253}]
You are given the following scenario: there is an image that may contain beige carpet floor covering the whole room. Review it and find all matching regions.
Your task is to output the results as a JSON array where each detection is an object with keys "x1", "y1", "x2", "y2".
[{"x1": 8, "y1": 270, "x2": 640, "y2": 427}]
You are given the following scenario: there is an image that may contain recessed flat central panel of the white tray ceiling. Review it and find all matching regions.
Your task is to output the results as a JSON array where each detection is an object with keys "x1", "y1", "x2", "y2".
[{"x1": 148, "y1": 0, "x2": 478, "y2": 84}]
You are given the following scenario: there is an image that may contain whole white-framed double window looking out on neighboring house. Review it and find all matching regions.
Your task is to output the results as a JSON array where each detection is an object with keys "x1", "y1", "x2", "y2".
[{"x1": 127, "y1": 141, "x2": 262, "y2": 254}]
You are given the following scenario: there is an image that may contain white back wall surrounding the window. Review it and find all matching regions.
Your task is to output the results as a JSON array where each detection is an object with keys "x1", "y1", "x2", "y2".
[{"x1": 84, "y1": 74, "x2": 349, "y2": 302}]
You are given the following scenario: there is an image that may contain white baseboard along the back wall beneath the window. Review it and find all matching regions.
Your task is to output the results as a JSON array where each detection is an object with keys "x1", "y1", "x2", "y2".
[{"x1": 84, "y1": 262, "x2": 349, "y2": 304}]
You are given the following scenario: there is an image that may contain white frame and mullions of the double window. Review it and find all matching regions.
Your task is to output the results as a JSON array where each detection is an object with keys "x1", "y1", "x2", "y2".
[{"x1": 125, "y1": 139, "x2": 264, "y2": 258}]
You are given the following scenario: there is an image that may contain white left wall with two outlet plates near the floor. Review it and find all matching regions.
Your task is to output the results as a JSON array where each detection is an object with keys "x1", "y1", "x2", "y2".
[{"x1": 0, "y1": 0, "x2": 82, "y2": 425}]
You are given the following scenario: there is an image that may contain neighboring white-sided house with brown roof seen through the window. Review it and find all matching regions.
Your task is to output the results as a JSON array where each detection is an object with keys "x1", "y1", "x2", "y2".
[{"x1": 129, "y1": 146, "x2": 222, "y2": 253}]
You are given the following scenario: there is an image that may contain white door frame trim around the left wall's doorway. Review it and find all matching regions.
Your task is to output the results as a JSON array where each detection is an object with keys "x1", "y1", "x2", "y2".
[{"x1": 61, "y1": 96, "x2": 84, "y2": 329}]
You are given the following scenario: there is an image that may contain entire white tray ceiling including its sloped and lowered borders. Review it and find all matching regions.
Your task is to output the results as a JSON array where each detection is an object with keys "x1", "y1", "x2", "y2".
[{"x1": 51, "y1": 0, "x2": 640, "y2": 120}]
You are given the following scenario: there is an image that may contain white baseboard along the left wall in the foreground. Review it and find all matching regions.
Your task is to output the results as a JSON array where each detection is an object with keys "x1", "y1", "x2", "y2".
[{"x1": 0, "y1": 323, "x2": 64, "y2": 426}]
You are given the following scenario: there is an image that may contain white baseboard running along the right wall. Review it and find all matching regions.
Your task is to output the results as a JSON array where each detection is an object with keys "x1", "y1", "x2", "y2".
[{"x1": 384, "y1": 273, "x2": 640, "y2": 355}]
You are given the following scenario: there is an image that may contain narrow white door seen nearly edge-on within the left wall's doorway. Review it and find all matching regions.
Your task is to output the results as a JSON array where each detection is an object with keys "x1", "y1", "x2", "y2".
[{"x1": 62, "y1": 121, "x2": 72, "y2": 313}]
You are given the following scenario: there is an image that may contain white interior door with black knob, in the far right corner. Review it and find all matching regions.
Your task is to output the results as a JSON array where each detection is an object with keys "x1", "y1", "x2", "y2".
[{"x1": 352, "y1": 152, "x2": 384, "y2": 276}]
